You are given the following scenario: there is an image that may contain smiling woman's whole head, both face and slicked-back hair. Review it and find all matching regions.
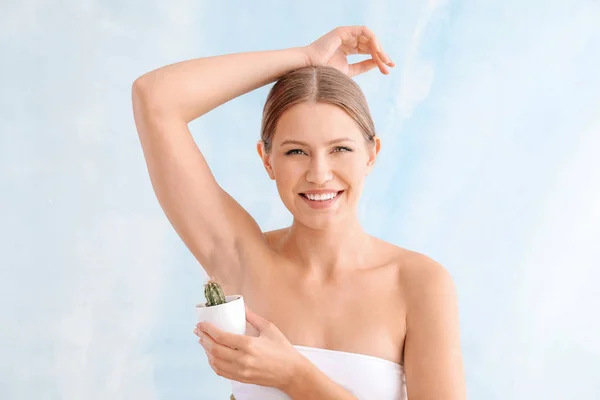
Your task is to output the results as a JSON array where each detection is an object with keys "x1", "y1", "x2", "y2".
[{"x1": 257, "y1": 93, "x2": 380, "y2": 223}]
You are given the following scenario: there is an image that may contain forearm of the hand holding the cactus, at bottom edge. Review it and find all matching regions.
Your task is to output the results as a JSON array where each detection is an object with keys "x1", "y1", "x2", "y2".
[{"x1": 281, "y1": 360, "x2": 357, "y2": 400}]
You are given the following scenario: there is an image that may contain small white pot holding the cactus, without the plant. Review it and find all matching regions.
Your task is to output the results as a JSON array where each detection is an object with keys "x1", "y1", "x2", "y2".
[{"x1": 196, "y1": 294, "x2": 246, "y2": 335}]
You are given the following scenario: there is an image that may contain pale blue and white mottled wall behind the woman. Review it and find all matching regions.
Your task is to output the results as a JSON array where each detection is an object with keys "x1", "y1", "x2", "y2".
[{"x1": 0, "y1": 0, "x2": 600, "y2": 400}]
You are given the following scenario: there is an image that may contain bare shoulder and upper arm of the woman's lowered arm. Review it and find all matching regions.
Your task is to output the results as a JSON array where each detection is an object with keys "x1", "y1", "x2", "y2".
[{"x1": 401, "y1": 248, "x2": 466, "y2": 400}]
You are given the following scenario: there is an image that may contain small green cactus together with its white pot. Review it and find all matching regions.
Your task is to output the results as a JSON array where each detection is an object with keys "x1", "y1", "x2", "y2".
[{"x1": 196, "y1": 279, "x2": 246, "y2": 335}]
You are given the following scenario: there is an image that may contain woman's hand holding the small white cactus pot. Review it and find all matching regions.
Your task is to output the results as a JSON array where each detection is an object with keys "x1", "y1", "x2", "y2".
[{"x1": 194, "y1": 307, "x2": 306, "y2": 389}]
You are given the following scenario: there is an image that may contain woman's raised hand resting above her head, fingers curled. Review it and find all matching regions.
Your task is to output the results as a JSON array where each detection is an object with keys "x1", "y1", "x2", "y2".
[{"x1": 304, "y1": 26, "x2": 396, "y2": 77}]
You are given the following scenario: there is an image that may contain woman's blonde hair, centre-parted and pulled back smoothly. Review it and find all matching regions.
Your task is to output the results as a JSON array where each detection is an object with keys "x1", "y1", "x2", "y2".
[{"x1": 261, "y1": 66, "x2": 375, "y2": 153}]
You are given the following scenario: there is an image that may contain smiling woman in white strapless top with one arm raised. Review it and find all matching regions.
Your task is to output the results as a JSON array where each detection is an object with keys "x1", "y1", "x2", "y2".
[{"x1": 132, "y1": 26, "x2": 465, "y2": 400}]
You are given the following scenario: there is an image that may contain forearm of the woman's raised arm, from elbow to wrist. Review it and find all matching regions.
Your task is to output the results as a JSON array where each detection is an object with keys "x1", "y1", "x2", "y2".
[{"x1": 133, "y1": 47, "x2": 309, "y2": 122}]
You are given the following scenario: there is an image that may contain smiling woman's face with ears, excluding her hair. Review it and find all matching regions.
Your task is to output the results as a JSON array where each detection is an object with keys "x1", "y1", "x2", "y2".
[{"x1": 258, "y1": 102, "x2": 380, "y2": 229}]
